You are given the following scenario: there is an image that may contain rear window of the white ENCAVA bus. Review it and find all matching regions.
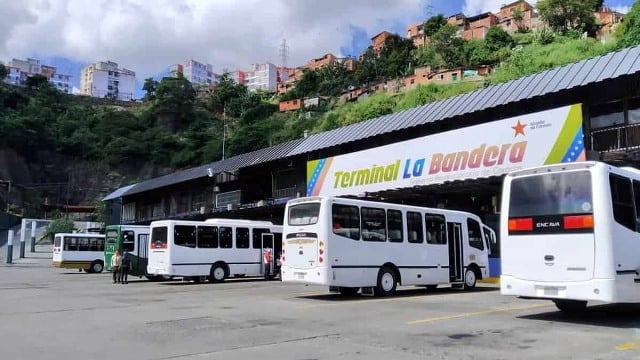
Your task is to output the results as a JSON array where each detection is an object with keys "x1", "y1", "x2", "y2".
[{"x1": 509, "y1": 171, "x2": 593, "y2": 218}]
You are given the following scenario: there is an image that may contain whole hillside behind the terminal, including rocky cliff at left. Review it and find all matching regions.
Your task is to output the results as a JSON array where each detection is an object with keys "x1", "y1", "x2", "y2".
[{"x1": 0, "y1": 3, "x2": 640, "y2": 216}]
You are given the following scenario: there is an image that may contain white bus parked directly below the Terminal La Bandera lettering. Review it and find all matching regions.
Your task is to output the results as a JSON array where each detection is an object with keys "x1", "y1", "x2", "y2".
[{"x1": 282, "y1": 197, "x2": 495, "y2": 296}]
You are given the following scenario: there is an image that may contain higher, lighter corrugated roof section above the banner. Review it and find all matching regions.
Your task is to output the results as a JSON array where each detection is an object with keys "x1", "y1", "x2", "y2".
[{"x1": 289, "y1": 46, "x2": 640, "y2": 156}]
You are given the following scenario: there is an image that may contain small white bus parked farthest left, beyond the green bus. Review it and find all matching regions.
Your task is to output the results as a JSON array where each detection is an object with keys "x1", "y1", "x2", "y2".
[{"x1": 53, "y1": 233, "x2": 104, "y2": 273}]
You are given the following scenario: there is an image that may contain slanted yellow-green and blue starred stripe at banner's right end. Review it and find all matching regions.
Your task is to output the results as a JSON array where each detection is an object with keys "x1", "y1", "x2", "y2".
[{"x1": 544, "y1": 104, "x2": 586, "y2": 165}]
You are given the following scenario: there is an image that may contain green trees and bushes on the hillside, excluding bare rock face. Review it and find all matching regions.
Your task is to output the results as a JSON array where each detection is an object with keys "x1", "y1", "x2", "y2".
[{"x1": 0, "y1": 0, "x2": 640, "y2": 211}]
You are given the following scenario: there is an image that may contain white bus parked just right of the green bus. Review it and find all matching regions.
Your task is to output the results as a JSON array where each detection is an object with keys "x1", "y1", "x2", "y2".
[{"x1": 147, "y1": 219, "x2": 282, "y2": 282}]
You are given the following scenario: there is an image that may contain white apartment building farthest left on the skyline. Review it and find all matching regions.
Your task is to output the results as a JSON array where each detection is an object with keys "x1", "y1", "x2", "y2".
[{"x1": 5, "y1": 58, "x2": 73, "y2": 94}]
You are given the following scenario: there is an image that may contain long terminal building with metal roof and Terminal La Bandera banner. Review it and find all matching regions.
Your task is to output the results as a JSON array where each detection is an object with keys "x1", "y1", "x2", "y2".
[{"x1": 104, "y1": 47, "x2": 640, "y2": 250}]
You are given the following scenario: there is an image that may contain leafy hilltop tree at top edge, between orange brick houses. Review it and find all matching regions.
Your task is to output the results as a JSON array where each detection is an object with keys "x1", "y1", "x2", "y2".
[{"x1": 537, "y1": 0, "x2": 598, "y2": 34}]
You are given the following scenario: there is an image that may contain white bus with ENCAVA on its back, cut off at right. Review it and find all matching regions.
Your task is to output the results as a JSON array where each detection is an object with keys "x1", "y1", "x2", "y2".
[{"x1": 500, "y1": 161, "x2": 640, "y2": 311}]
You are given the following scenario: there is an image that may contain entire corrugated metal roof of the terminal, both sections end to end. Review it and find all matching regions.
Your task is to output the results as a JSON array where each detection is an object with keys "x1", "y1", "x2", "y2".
[{"x1": 122, "y1": 46, "x2": 640, "y2": 195}]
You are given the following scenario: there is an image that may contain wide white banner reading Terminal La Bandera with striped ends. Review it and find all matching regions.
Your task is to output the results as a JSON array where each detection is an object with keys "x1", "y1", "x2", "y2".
[{"x1": 307, "y1": 104, "x2": 585, "y2": 196}]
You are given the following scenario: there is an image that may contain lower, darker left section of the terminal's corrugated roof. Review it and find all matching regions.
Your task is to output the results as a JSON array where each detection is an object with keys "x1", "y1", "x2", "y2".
[{"x1": 123, "y1": 138, "x2": 305, "y2": 196}]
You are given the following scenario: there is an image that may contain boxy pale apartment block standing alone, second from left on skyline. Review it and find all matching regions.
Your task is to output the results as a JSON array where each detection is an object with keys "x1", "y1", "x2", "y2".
[{"x1": 80, "y1": 61, "x2": 136, "y2": 101}]
